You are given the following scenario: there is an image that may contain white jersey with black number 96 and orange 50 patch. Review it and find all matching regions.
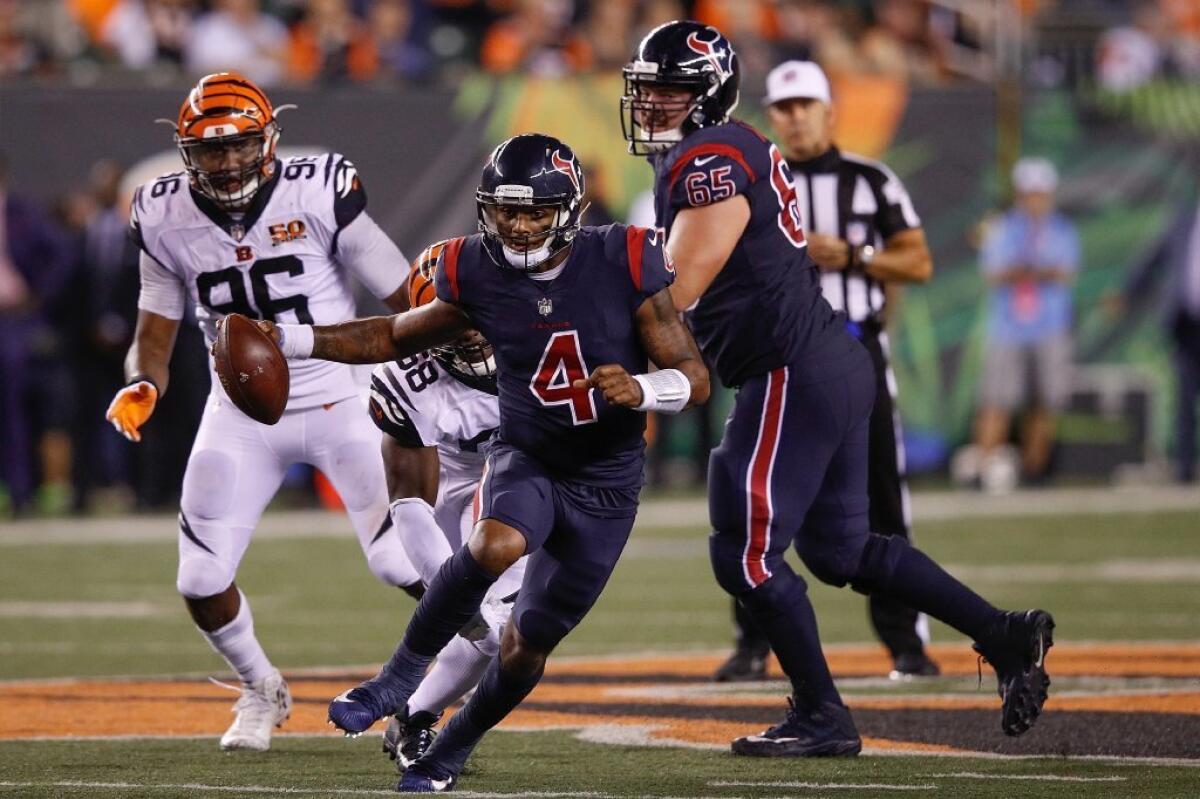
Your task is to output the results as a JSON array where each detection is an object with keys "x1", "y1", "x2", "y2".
[{"x1": 131, "y1": 154, "x2": 408, "y2": 410}]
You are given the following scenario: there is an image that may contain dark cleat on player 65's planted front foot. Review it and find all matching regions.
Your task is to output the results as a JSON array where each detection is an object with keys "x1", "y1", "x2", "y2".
[{"x1": 732, "y1": 697, "x2": 863, "y2": 757}]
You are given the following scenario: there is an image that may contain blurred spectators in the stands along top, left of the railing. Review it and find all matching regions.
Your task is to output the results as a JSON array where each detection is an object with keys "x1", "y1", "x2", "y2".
[{"x1": 0, "y1": 0, "x2": 1028, "y2": 86}]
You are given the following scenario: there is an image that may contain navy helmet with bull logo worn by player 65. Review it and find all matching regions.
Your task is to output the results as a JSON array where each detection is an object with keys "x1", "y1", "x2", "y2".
[{"x1": 620, "y1": 20, "x2": 742, "y2": 155}]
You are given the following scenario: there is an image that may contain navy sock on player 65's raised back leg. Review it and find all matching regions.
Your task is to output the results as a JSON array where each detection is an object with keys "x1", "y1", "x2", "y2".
[{"x1": 884, "y1": 537, "x2": 1001, "y2": 641}]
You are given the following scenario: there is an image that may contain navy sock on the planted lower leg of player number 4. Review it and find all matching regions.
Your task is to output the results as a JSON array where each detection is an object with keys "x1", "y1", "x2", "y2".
[{"x1": 420, "y1": 657, "x2": 544, "y2": 779}]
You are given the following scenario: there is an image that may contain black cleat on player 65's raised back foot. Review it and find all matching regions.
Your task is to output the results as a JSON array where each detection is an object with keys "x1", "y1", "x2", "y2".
[{"x1": 974, "y1": 611, "x2": 1054, "y2": 737}]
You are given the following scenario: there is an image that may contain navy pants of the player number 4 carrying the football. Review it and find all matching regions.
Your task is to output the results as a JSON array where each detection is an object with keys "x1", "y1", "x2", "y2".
[{"x1": 479, "y1": 443, "x2": 641, "y2": 650}]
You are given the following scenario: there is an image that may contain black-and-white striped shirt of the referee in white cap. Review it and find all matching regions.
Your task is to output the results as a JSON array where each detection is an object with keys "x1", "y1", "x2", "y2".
[{"x1": 788, "y1": 148, "x2": 920, "y2": 323}]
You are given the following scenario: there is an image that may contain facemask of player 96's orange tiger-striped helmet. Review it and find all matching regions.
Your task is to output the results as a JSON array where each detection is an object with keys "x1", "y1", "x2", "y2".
[{"x1": 175, "y1": 122, "x2": 280, "y2": 211}]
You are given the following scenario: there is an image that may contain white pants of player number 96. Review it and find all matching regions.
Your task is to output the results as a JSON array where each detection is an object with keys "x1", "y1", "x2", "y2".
[{"x1": 176, "y1": 392, "x2": 420, "y2": 599}]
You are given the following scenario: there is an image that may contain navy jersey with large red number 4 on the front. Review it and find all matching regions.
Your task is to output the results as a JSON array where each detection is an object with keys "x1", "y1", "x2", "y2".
[{"x1": 434, "y1": 224, "x2": 674, "y2": 487}]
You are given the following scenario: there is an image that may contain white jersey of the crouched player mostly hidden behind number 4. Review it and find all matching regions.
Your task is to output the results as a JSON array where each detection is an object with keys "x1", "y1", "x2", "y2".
[{"x1": 371, "y1": 353, "x2": 500, "y2": 491}]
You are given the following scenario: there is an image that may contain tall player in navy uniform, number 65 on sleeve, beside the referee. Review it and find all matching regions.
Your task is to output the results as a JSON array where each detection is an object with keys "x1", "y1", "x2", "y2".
[{"x1": 620, "y1": 22, "x2": 1054, "y2": 756}]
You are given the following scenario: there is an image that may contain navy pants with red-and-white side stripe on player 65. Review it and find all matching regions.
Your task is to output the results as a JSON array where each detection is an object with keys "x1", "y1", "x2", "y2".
[{"x1": 708, "y1": 350, "x2": 875, "y2": 596}]
